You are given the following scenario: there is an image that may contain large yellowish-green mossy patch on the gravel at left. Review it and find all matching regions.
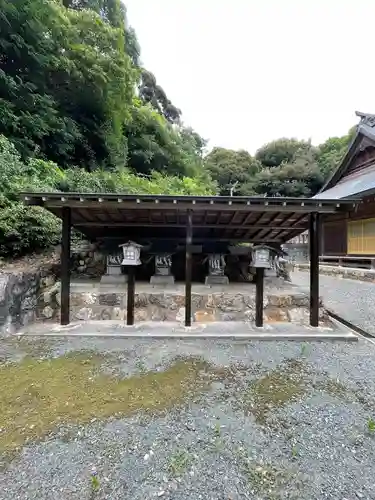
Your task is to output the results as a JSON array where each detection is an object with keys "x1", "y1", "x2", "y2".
[{"x1": 0, "y1": 352, "x2": 215, "y2": 454}]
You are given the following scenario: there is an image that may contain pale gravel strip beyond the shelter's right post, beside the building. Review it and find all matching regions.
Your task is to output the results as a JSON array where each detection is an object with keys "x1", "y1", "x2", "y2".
[{"x1": 292, "y1": 271, "x2": 375, "y2": 334}]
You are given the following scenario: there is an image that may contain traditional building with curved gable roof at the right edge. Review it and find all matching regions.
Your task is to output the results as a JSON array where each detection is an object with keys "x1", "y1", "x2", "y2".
[{"x1": 314, "y1": 112, "x2": 375, "y2": 260}]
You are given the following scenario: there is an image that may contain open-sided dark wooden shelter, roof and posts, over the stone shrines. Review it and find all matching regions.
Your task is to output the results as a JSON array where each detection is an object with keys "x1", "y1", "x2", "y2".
[{"x1": 21, "y1": 192, "x2": 356, "y2": 326}]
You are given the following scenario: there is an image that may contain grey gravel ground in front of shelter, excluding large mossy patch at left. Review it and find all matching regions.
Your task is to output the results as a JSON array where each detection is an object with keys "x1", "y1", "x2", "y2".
[{"x1": 0, "y1": 337, "x2": 375, "y2": 500}]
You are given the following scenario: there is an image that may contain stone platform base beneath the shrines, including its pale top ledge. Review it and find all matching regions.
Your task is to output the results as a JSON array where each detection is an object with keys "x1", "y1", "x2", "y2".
[{"x1": 39, "y1": 282, "x2": 329, "y2": 325}]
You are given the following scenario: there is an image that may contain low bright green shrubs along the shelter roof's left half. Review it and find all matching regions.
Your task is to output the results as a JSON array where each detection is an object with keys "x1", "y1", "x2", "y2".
[{"x1": 0, "y1": 136, "x2": 215, "y2": 257}]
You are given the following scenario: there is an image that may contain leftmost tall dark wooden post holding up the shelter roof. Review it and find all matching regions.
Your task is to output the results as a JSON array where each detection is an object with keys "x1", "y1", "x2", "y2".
[{"x1": 60, "y1": 207, "x2": 71, "y2": 325}]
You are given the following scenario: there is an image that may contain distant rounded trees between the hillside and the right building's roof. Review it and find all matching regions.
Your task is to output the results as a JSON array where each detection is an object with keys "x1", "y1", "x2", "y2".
[{"x1": 205, "y1": 133, "x2": 355, "y2": 197}]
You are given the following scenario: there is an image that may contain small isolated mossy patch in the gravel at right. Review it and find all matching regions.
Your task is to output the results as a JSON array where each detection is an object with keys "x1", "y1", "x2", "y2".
[{"x1": 243, "y1": 360, "x2": 307, "y2": 425}]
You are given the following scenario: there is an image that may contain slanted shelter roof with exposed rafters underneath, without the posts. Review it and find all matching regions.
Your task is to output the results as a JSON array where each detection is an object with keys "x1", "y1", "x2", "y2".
[{"x1": 21, "y1": 192, "x2": 357, "y2": 243}]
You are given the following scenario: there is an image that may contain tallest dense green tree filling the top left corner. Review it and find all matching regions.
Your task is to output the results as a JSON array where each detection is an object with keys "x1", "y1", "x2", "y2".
[{"x1": 0, "y1": 0, "x2": 136, "y2": 168}]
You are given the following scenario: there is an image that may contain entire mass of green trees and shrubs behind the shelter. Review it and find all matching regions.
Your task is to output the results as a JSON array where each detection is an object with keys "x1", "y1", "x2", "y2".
[{"x1": 0, "y1": 0, "x2": 353, "y2": 256}]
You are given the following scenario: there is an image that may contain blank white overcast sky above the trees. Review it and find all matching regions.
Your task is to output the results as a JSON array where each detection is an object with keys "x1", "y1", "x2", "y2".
[{"x1": 125, "y1": 0, "x2": 375, "y2": 153}]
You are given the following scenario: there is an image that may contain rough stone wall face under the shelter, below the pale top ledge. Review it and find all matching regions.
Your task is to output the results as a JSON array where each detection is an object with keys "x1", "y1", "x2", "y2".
[{"x1": 39, "y1": 286, "x2": 328, "y2": 324}]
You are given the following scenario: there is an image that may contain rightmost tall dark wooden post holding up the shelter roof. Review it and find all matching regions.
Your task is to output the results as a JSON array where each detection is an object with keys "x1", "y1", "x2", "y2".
[{"x1": 309, "y1": 213, "x2": 321, "y2": 326}]
